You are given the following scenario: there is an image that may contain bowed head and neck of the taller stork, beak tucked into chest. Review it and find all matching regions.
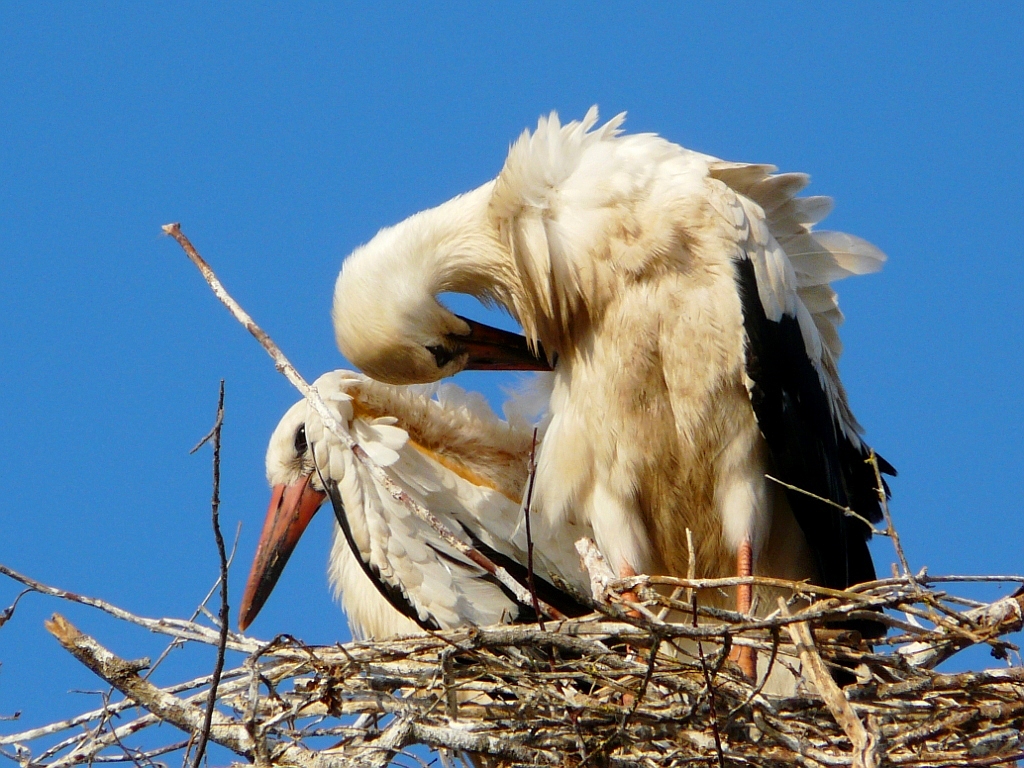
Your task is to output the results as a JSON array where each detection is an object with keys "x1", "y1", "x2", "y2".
[{"x1": 332, "y1": 184, "x2": 550, "y2": 384}]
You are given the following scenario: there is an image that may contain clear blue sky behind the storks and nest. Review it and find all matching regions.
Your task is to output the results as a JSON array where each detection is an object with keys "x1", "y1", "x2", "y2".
[{"x1": 0, "y1": 2, "x2": 1024, "y2": 765}]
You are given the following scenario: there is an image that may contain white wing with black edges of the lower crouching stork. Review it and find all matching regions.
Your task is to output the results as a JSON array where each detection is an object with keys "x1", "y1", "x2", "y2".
[{"x1": 306, "y1": 379, "x2": 581, "y2": 630}]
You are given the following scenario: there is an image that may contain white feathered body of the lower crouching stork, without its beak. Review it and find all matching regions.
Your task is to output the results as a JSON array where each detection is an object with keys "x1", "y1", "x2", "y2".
[{"x1": 267, "y1": 372, "x2": 586, "y2": 639}]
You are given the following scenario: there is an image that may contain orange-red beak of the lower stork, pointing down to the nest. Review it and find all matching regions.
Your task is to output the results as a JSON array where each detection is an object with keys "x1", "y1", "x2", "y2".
[{"x1": 239, "y1": 475, "x2": 327, "y2": 632}]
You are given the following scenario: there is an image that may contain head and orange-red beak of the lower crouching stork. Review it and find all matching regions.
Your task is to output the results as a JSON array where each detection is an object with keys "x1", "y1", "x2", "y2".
[{"x1": 239, "y1": 400, "x2": 327, "y2": 631}]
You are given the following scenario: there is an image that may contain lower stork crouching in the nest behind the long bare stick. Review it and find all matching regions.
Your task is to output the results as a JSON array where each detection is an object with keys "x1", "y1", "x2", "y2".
[{"x1": 239, "y1": 371, "x2": 589, "y2": 639}]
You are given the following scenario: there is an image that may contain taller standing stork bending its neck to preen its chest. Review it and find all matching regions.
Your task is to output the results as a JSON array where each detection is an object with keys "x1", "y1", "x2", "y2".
[{"x1": 333, "y1": 109, "x2": 893, "y2": 655}]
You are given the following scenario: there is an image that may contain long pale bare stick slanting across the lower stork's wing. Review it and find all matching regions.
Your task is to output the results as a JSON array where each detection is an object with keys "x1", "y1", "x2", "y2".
[{"x1": 163, "y1": 223, "x2": 565, "y2": 621}]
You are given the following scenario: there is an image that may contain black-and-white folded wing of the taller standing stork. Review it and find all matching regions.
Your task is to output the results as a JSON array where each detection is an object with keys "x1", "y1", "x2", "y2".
[{"x1": 711, "y1": 161, "x2": 895, "y2": 589}]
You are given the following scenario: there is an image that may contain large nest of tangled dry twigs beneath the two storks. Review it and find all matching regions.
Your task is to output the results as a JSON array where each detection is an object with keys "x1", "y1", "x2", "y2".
[{"x1": 0, "y1": 566, "x2": 1024, "y2": 768}]
